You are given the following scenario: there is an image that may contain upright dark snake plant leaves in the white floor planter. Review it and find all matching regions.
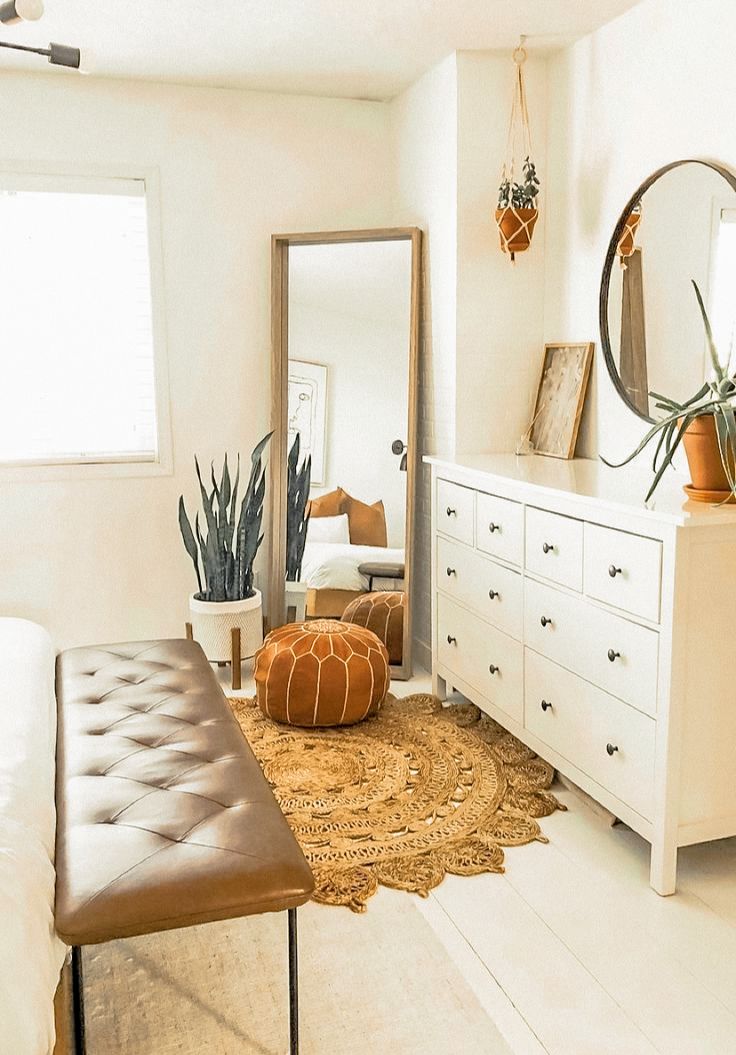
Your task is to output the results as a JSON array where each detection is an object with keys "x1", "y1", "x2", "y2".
[{"x1": 179, "y1": 433, "x2": 273, "y2": 601}]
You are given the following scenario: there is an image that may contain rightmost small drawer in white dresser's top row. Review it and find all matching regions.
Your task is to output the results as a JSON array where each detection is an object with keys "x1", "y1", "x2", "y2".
[{"x1": 583, "y1": 523, "x2": 662, "y2": 622}]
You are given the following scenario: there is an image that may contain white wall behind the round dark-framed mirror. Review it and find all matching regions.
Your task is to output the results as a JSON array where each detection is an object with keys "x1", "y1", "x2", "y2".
[{"x1": 544, "y1": 0, "x2": 736, "y2": 457}]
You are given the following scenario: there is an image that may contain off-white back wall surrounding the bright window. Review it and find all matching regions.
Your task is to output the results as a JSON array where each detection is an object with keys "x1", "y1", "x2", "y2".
[{"x1": 0, "y1": 74, "x2": 390, "y2": 647}]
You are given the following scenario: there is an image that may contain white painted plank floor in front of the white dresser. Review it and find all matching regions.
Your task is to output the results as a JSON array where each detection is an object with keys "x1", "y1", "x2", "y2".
[{"x1": 223, "y1": 676, "x2": 736, "y2": 1055}]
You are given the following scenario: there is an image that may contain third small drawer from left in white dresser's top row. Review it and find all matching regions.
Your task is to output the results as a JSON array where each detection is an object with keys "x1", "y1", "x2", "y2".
[{"x1": 524, "y1": 506, "x2": 583, "y2": 590}]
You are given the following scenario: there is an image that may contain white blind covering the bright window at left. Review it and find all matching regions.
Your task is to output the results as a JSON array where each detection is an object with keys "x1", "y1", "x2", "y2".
[{"x1": 0, "y1": 174, "x2": 158, "y2": 464}]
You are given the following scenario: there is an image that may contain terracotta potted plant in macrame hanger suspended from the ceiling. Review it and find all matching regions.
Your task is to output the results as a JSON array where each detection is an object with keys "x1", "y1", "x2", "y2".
[{"x1": 496, "y1": 37, "x2": 539, "y2": 262}]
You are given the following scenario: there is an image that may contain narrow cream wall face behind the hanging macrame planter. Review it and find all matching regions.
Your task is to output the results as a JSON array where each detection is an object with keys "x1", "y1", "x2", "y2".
[{"x1": 456, "y1": 52, "x2": 548, "y2": 454}]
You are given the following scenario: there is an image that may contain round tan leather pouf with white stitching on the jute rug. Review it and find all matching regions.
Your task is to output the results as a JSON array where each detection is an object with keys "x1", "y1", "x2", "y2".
[{"x1": 255, "y1": 619, "x2": 389, "y2": 726}]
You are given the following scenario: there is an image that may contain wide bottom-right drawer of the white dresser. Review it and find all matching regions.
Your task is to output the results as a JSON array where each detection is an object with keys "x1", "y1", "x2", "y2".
[{"x1": 524, "y1": 649, "x2": 656, "y2": 819}]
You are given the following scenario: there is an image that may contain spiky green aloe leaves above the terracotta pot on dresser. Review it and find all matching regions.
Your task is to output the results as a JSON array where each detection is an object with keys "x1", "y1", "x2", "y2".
[{"x1": 601, "y1": 279, "x2": 736, "y2": 500}]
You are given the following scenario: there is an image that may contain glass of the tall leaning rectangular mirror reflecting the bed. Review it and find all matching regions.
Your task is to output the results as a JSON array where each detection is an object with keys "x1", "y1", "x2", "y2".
[{"x1": 267, "y1": 230, "x2": 417, "y2": 676}]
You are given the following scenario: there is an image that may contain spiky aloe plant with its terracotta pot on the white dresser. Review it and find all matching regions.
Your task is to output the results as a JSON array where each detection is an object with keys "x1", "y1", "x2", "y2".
[{"x1": 601, "y1": 280, "x2": 736, "y2": 502}]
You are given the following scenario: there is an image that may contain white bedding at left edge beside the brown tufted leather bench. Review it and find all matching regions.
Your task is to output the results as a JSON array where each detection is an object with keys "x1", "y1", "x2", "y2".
[{"x1": 0, "y1": 618, "x2": 66, "y2": 1055}]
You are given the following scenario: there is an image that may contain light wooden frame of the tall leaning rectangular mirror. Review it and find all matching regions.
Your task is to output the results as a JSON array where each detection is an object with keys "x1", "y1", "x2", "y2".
[{"x1": 268, "y1": 227, "x2": 422, "y2": 680}]
